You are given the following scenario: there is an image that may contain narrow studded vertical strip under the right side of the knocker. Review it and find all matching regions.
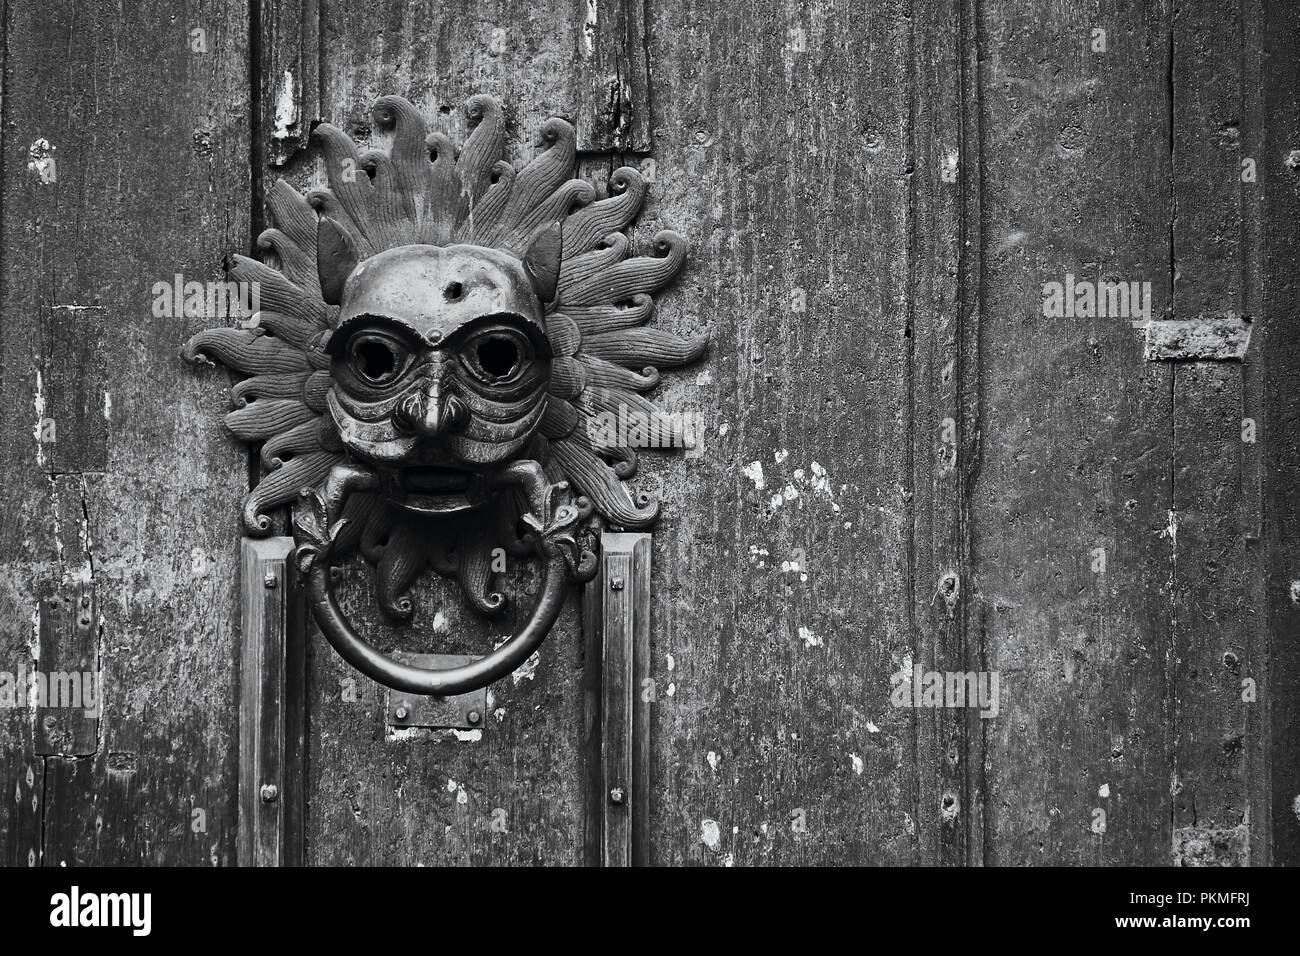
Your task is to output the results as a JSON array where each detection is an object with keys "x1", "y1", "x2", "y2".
[{"x1": 582, "y1": 532, "x2": 655, "y2": 866}]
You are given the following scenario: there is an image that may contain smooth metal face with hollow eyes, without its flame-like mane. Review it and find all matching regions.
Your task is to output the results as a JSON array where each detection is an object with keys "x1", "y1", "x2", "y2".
[{"x1": 326, "y1": 245, "x2": 551, "y2": 514}]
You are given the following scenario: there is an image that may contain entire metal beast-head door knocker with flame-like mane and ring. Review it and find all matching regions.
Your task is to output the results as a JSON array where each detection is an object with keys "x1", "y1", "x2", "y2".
[{"x1": 186, "y1": 96, "x2": 707, "y2": 696}]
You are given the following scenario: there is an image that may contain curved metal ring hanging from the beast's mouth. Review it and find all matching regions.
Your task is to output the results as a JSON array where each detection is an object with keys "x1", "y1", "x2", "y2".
[{"x1": 307, "y1": 550, "x2": 569, "y2": 697}]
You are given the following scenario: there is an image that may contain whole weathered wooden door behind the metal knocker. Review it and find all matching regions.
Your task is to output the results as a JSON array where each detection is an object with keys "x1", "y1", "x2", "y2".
[{"x1": 0, "y1": 0, "x2": 1300, "y2": 866}]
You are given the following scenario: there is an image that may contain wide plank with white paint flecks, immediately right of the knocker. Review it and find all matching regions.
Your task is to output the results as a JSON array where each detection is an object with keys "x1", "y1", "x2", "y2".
[{"x1": 638, "y1": 0, "x2": 915, "y2": 866}]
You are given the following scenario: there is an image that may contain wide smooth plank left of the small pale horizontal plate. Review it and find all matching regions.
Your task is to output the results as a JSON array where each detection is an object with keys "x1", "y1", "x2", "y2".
[{"x1": 971, "y1": 0, "x2": 1174, "y2": 865}]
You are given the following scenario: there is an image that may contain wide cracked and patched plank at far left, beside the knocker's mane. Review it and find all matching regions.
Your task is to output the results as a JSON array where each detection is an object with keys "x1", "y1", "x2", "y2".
[{"x1": 0, "y1": 0, "x2": 250, "y2": 865}]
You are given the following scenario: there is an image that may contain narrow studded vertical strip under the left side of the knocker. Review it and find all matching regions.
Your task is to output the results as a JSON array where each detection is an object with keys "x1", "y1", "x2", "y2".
[{"x1": 238, "y1": 537, "x2": 306, "y2": 866}]
